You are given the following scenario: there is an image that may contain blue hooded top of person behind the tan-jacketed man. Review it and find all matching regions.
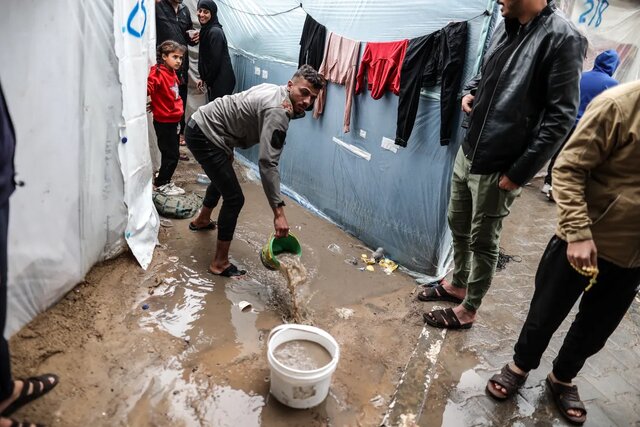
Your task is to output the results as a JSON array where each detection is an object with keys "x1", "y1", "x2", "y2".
[{"x1": 576, "y1": 49, "x2": 620, "y2": 123}]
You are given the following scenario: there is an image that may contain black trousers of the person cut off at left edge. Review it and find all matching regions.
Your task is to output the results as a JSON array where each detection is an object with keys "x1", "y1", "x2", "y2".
[{"x1": 0, "y1": 201, "x2": 13, "y2": 400}]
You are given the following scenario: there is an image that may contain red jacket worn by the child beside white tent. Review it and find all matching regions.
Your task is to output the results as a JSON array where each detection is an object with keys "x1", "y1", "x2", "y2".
[{"x1": 147, "y1": 64, "x2": 184, "y2": 123}]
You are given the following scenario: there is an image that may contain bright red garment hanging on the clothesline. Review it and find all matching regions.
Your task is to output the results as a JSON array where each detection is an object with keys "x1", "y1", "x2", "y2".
[{"x1": 356, "y1": 40, "x2": 409, "y2": 99}]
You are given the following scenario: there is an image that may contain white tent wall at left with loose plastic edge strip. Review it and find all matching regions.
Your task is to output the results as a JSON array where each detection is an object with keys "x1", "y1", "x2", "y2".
[{"x1": 0, "y1": 0, "x2": 158, "y2": 336}]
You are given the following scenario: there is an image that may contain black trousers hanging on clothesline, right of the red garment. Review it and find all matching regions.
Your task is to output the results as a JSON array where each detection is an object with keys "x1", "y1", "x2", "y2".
[{"x1": 396, "y1": 22, "x2": 467, "y2": 147}]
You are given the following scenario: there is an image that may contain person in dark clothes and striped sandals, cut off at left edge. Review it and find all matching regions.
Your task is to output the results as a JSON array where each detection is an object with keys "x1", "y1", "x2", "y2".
[{"x1": 0, "y1": 80, "x2": 59, "y2": 427}]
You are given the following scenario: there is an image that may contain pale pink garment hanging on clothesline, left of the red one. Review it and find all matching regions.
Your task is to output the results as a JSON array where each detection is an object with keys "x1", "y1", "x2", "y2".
[{"x1": 313, "y1": 33, "x2": 360, "y2": 133}]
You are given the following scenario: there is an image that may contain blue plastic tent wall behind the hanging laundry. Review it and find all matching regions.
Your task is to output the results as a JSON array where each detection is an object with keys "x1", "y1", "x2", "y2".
[{"x1": 218, "y1": 1, "x2": 492, "y2": 276}]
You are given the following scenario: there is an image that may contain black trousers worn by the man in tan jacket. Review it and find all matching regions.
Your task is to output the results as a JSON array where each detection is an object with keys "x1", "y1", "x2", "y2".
[{"x1": 513, "y1": 236, "x2": 640, "y2": 382}]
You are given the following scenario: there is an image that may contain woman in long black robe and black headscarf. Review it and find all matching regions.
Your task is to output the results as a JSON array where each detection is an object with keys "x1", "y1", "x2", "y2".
[{"x1": 198, "y1": 0, "x2": 236, "y2": 102}]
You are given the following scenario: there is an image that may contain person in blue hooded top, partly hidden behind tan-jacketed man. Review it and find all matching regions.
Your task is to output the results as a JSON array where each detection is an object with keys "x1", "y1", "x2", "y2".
[{"x1": 541, "y1": 49, "x2": 620, "y2": 201}]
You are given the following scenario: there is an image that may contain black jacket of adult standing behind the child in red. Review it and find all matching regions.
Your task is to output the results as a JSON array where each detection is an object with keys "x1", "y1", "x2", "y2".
[{"x1": 156, "y1": 0, "x2": 196, "y2": 85}]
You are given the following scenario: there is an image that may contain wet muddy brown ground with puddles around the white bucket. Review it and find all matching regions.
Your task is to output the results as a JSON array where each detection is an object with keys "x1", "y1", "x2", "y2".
[{"x1": 10, "y1": 151, "x2": 422, "y2": 426}]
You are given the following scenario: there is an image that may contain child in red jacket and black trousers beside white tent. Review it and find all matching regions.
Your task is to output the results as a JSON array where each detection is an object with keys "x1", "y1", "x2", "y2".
[{"x1": 147, "y1": 40, "x2": 186, "y2": 196}]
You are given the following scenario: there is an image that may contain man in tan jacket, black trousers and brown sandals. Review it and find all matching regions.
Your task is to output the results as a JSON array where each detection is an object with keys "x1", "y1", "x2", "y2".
[{"x1": 487, "y1": 81, "x2": 640, "y2": 424}]
